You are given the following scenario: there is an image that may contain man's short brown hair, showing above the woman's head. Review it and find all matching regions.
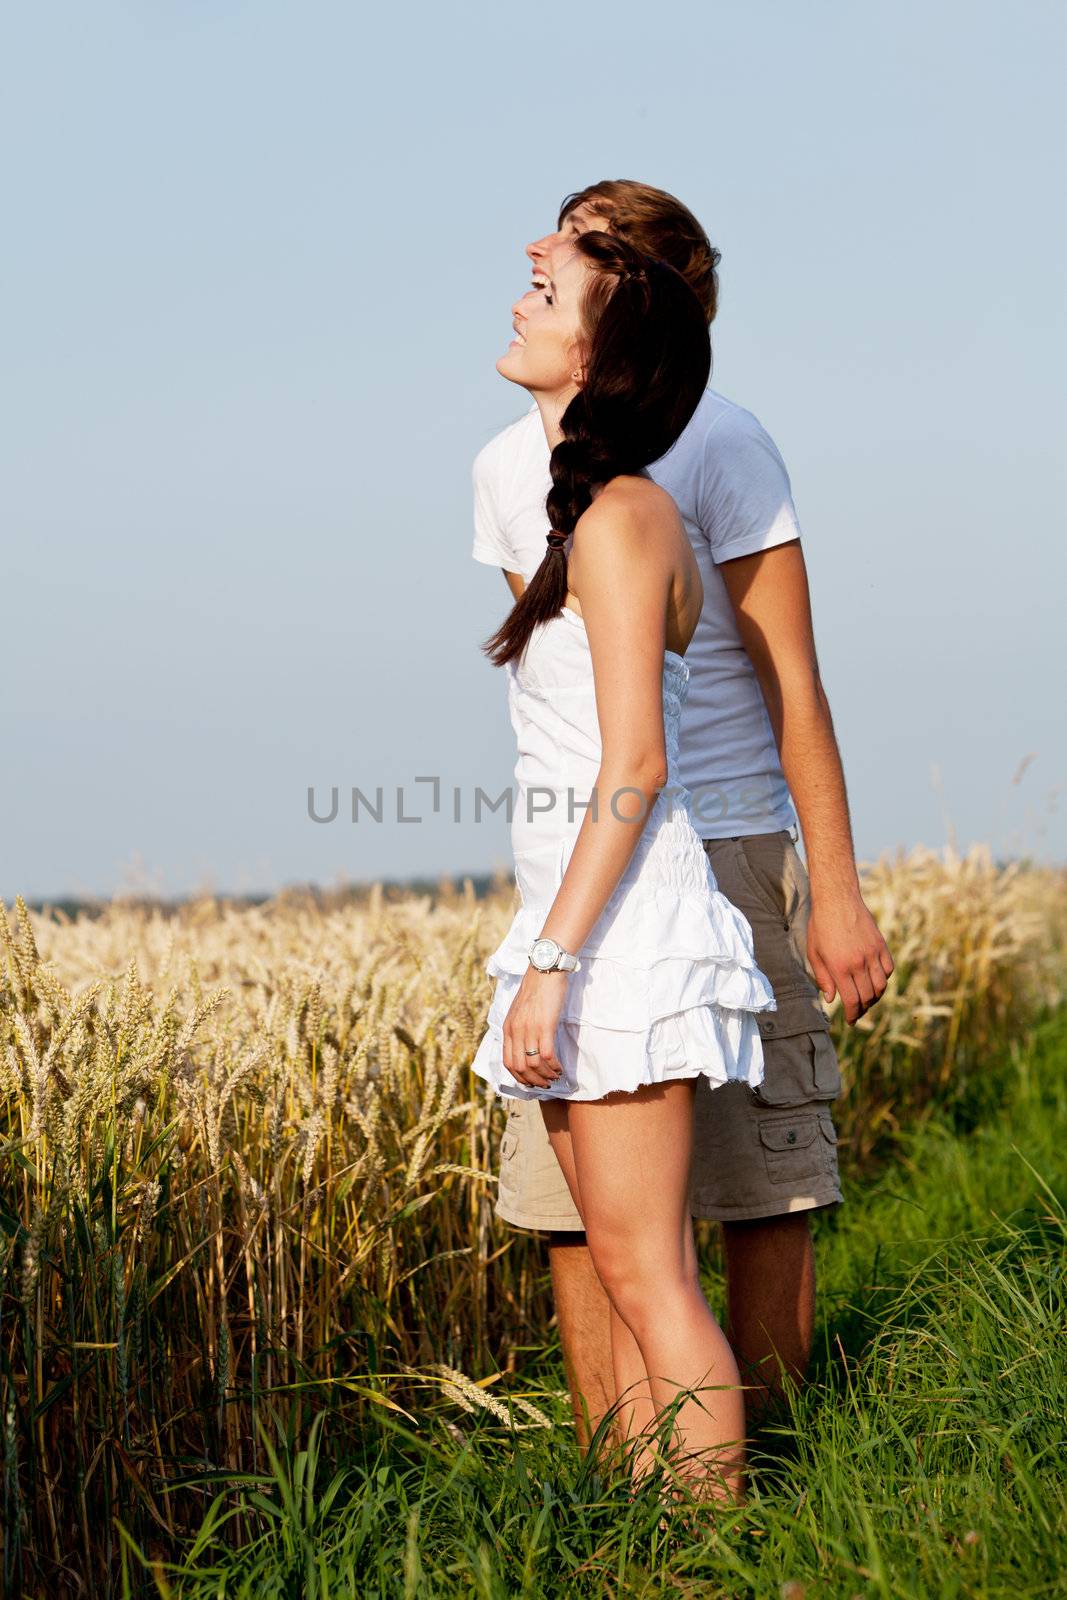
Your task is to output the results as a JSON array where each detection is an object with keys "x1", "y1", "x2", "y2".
[{"x1": 560, "y1": 178, "x2": 721, "y2": 323}]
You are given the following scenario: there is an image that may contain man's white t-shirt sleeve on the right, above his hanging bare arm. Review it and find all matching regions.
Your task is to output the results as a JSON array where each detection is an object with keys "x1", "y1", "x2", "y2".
[{"x1": 697, "y1": 408, "x2": 800, "y2": 563}]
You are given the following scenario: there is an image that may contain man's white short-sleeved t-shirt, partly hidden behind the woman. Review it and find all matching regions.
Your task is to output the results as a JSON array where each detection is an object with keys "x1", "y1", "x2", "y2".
[{"x1": 472, "y1": 389, "x2": 800, "y2": 838}]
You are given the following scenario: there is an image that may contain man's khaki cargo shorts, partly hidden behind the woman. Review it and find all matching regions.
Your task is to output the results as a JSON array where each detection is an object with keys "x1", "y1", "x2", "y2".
[{"x1": 496, "y1": 829, "x2": 841, "y2": 1232}]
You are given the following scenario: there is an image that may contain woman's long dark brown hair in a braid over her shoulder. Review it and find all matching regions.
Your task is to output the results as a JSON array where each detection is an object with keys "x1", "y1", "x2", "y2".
[{"x1": 482, "y1": 234, "x2": 712, "y2": 667}]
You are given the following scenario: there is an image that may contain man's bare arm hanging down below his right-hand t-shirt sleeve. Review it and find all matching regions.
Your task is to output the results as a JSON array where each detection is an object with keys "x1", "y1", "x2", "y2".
[{"x1": 718, "y1": 539, "x2": 893, "y2": 1022}]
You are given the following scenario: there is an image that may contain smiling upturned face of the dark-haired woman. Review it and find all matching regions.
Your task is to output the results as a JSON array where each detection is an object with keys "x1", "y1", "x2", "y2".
[{"x1": 496, "y1": 251, "x2": 592, "y2": 394}]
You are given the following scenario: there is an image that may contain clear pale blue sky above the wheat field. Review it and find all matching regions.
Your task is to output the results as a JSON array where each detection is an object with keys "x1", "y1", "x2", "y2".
[{"x1": 0, "y1": 0, "x2": 1067, "y2": 902}]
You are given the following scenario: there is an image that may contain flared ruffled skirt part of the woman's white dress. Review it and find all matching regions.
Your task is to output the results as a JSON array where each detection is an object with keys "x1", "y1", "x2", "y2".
[{"x1": 472, "y1": 808, "x2": 776, "y2": 1101}]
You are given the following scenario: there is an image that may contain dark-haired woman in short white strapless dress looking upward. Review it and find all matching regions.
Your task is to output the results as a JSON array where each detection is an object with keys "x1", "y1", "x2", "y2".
[{"x1": 474, "y1": 232, "x2": 774, "y2": 1496}]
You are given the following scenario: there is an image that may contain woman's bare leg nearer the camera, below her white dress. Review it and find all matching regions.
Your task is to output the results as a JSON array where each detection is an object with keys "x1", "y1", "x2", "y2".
[{"x1": 566, "y1": 1078, "x2": 744, "y2": 1498}]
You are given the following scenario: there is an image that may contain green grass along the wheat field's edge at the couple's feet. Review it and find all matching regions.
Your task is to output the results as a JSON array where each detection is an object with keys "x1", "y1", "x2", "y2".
[{"x1": 128, "y1": 1014, "x2": 1067, "y2": 1600}]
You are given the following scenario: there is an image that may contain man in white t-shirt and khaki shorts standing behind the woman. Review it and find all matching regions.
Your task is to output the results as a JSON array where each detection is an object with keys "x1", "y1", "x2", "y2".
[{"x1": 472, "y1": 181, "x2": 893, "y2": 1443}]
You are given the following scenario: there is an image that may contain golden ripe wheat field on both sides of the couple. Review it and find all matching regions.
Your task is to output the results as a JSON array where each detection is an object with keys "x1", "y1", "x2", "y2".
[{"x1": 0, "y1": 848, "x2": 1067, "y2": 1595}]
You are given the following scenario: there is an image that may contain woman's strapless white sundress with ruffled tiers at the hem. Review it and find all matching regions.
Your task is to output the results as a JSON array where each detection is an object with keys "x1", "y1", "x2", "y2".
[{"x1": 472, "y1": 605, "x2": 776, "y2": 1101}]
